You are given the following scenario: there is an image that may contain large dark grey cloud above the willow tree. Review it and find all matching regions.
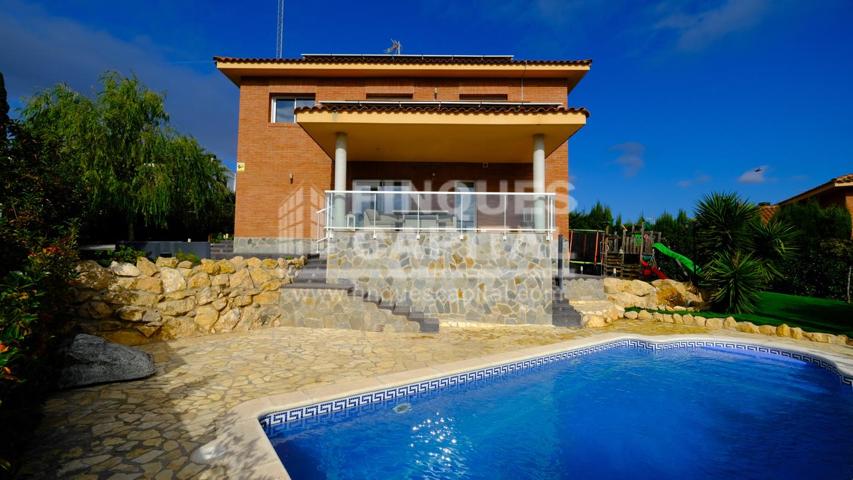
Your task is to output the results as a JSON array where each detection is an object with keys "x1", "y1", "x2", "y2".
[{"x1": 0, "y1": 0, "x2": 238, "y2": 167}]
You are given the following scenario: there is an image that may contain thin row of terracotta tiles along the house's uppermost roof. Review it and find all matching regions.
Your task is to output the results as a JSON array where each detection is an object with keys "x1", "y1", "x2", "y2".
[{"x1": 213, "y1": 55, "x2": 592, "y2": 66}]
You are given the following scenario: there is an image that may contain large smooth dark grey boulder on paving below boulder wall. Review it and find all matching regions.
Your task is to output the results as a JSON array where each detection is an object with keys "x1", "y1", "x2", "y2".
[{"x1": 58, "y1": 333, "x2": 156, "y2": 388}]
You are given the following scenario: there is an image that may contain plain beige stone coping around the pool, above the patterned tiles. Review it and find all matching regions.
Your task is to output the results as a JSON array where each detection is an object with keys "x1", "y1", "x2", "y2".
[{"x1": 201, "y1": 333, "x2": 853, "y2": 480}]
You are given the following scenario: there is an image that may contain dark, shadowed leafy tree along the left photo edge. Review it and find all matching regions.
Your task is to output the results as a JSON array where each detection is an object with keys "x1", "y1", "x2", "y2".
[{"x1": 0, "y1": 71, "x2": 83, "y2": 477}]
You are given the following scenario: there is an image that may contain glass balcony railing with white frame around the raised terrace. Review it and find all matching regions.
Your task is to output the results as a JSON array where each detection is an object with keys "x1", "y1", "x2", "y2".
[{"x1": 318, "y1": 190, "x2": 555, "y2": 233}]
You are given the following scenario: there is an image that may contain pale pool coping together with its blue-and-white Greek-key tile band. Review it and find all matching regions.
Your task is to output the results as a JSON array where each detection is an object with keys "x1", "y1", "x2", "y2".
[{"x1": 208, "y1": 333, "x2": 853, "y2": 479}]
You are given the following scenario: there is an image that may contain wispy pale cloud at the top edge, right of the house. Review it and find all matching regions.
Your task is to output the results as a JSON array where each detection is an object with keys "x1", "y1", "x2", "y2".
[{"x1": 655, "y1": 0, "x2": 769, "y2": 51}]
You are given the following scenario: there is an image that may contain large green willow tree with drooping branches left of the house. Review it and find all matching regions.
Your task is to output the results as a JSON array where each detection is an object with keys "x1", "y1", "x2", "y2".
[{"x1": 22, "y1": 72, "x2": 233, "y2": 240}]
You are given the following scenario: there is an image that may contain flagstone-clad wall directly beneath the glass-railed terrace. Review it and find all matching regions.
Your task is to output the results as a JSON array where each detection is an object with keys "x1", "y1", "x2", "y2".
[{"x1": 326, "y1": 231, "x2": 555, "y2": 324}]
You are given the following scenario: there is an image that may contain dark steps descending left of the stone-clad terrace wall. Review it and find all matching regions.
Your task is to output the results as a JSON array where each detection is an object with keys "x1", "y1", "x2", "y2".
[{"x1": 287, "y1": 254, "x2": 439, "y2": 333}]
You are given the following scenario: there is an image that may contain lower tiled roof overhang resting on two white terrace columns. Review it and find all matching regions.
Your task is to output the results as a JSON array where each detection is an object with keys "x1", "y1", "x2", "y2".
[{"x1": 296, "y1": 108, "x2": 587, "y2": 163}]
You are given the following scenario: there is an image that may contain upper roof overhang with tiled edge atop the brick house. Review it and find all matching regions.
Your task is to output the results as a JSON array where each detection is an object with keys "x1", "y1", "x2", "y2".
[{"x1": 214, "y1": 57, "x2": 590, "y2": 89}]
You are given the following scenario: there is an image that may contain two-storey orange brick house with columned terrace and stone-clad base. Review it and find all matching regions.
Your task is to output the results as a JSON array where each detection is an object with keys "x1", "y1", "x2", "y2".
[{"x1": 214, "y1": 54, "x2": 591, "y2": 323}]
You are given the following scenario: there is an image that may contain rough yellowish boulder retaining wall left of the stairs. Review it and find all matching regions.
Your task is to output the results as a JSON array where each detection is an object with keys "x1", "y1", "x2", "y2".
[{"x1": 73, "y1": 257, "x2": 304, "y2": 345}]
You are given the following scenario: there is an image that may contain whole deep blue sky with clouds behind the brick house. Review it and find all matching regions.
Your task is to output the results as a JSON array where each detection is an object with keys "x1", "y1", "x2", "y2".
[{"x1": 0, "y1": 0, "x2": 853, "y2": 218}]
